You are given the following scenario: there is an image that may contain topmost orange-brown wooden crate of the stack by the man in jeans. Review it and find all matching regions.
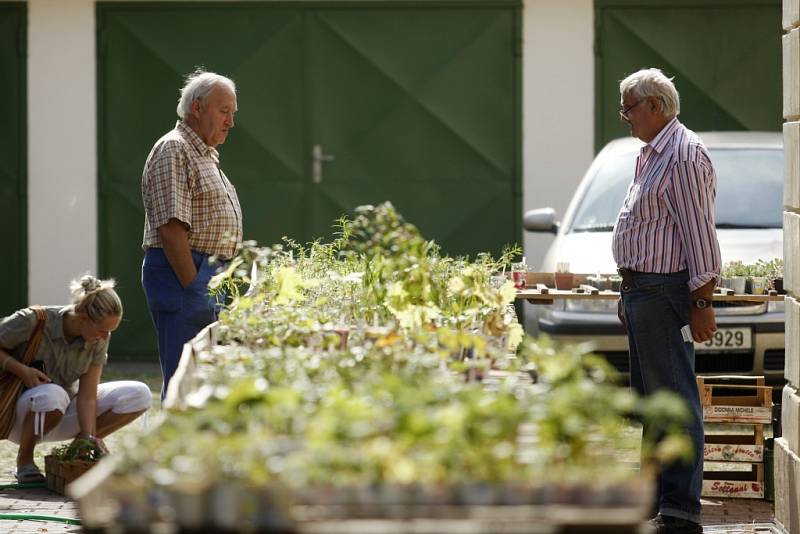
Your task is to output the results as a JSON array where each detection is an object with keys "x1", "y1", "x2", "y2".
[{"x1": 697, "y1": 375, "x2": 772, "y2": 423}]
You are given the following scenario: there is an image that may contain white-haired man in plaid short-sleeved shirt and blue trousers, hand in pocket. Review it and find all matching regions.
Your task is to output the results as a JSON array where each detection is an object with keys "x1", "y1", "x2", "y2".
[{"x1": 142, "y1": 70, "x2": 242, "y2": 399}]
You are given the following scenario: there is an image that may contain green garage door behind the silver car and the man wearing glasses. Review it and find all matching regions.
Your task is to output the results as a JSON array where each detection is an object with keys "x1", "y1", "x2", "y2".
[{"x1": 595, "y1": 0, "x2": 782, "y2": 149}]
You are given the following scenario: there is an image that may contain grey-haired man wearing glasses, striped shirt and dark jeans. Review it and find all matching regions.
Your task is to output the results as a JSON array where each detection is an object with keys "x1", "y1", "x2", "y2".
[{"x1": 612, "y1": 69, "x2": 720, "y2": 534}]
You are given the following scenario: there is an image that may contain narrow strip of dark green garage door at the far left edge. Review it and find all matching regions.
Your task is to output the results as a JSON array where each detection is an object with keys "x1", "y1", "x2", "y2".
[{"x1": 0, "y1": 2, "x2": 28, "y2": 317}]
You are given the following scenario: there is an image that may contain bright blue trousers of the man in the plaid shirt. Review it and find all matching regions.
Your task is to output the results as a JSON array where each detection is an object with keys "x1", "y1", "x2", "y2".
[{"x1": 142, "y1": 248, "x2": 219, "y2": 400}]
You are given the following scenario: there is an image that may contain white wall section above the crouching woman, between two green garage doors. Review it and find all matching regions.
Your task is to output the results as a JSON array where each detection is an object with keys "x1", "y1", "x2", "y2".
[{"x1": 28, "y1": 0, "x2": 97, "y2": 304}]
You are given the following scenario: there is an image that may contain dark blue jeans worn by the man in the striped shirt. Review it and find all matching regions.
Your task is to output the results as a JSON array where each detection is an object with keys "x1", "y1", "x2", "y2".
[{"x1": 622, "y1": 271, "x2": 704, "y2": 523}]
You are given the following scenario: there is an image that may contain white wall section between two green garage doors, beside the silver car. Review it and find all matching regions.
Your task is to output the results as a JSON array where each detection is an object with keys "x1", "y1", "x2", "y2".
[{"x1": 522, "y1": 0, "x2": 592, "y2": 269}]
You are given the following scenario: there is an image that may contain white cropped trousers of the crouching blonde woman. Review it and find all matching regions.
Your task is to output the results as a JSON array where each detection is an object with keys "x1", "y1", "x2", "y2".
[{"x1": 8, "y1": 380, "x2": 153, "y2": 444}]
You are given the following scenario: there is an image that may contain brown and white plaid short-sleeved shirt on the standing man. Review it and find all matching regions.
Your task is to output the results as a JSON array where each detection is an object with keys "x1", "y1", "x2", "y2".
[{"x1": 142, "y1": 121, "x2": 242, "y2": 259}]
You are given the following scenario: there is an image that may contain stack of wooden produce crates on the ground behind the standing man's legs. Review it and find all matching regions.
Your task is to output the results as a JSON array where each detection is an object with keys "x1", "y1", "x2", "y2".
[{"x1": 697, "y1": 376, "x2": 772, "y2": 499}]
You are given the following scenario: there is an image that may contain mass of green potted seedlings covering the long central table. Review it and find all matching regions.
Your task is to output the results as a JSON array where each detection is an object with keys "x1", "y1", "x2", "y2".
[{"x1": 109, "y1": 203, "x2": 692, "y2": 496}]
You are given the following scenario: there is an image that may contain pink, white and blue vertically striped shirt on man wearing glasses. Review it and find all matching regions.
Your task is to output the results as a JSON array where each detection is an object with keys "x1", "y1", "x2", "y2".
[{"x1": 612, "y1": 118, "x2": 721, "y2": 291}]
